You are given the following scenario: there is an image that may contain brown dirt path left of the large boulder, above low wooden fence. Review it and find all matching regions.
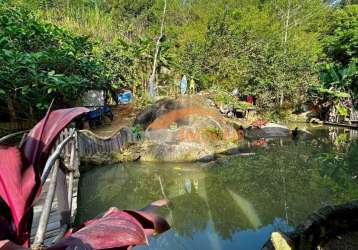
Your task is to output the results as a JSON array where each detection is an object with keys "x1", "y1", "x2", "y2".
[{"x1": 92, "y1": 104, "x2": 138, "y2": 136}]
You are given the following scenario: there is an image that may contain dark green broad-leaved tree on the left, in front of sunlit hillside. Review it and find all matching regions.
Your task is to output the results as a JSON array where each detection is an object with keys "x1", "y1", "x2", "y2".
[{"x1": 0, "y1": 5, "x2": 105, "y2": 120}]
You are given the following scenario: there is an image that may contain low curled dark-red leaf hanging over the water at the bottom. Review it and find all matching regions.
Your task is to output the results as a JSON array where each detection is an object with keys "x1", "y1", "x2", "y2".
[{"x1": 50, "y1": 208, "x2": 170, "y2": 250}]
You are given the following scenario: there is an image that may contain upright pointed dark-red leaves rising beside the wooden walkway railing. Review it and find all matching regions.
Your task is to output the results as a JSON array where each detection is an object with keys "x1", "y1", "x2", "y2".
[{"x1": 0, "y1": 108, "x2": 88, "y2": 245}]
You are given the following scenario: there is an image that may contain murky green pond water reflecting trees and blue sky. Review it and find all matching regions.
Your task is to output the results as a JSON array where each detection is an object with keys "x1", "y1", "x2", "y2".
[{"x1": 76, "y1": 127, "x2": 358, "y2": 250}]
